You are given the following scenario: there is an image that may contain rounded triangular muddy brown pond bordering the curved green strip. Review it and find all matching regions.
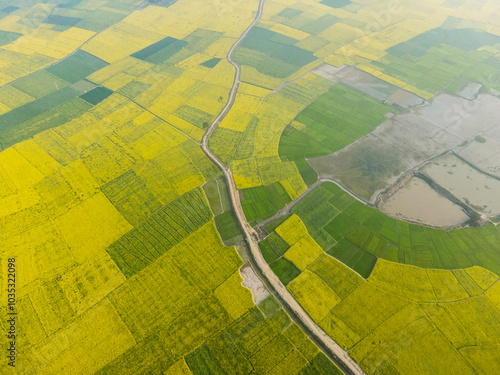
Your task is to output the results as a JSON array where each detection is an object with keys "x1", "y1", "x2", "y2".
[{"x1": 379, "y1": 177, "x2": 469, "y2": 227}]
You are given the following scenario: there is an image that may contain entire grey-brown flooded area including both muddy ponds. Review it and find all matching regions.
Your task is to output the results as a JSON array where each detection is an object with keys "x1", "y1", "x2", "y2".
[{"x1": 308, "y1": 76, "x2": 500, "y2": 227}]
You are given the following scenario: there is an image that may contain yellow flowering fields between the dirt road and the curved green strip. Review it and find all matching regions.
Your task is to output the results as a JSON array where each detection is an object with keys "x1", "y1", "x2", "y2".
[{"x1": 261, "y1": 214, "x2": 500, "y2": 373}]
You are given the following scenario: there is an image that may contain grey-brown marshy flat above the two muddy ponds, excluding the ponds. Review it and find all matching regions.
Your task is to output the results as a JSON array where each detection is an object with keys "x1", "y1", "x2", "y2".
[{"x1": 308, "y1": 94, "x2": 500, "y2": 207}]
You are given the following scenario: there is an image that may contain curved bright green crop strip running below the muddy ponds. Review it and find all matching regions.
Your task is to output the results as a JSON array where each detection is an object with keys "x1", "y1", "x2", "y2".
[{"x1": 288, "y1": 183, "x2": 500, "y2": 278}]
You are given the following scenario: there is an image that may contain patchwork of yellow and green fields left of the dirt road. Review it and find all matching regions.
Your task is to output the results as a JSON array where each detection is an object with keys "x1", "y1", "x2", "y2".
[{"x1": 0, "y1": 1, "x2": 340, "y2": 374}]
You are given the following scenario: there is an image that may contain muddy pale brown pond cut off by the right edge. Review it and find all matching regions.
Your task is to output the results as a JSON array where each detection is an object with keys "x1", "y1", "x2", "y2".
[{"x1": 422, "y1": 154, "x2": 500, "y2": 216}]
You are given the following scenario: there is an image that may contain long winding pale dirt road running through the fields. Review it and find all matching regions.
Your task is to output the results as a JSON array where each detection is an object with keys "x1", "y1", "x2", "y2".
[{"x1": 201, "y1": 0, "x2": 364, "y2": 374}]
